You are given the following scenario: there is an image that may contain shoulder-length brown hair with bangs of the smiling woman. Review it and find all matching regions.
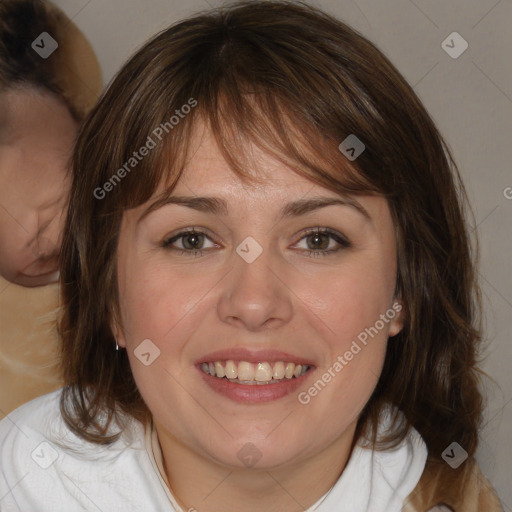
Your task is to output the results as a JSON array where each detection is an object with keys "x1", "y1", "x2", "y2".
[{"x1": 60, "y1": 1, "x2": 482, "y2": 464}]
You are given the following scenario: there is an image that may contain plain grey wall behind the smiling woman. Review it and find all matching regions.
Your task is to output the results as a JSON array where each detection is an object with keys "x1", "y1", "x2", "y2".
[{"x1": 55, "y1": 0, "x2": 512, "y2": 512}]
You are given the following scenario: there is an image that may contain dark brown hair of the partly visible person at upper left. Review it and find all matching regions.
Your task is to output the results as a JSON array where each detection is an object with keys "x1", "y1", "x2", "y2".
[{"x1": 0, "y1": 0, "x2": 102, "y2": 122}]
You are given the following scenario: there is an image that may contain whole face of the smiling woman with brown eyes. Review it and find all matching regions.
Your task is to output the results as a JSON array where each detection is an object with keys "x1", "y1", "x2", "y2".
[{"x1": 114, "y1": 122, "x2": 401, "y2": 468}]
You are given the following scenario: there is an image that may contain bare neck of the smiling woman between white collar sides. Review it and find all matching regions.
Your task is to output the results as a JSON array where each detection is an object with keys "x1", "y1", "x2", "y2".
[{"x1": 155, "y1": 423, "x2": 356, "y2": 512}]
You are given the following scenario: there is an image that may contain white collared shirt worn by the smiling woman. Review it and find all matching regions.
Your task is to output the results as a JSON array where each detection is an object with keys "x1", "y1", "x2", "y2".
[{"x1": 0, "y1": 390, "x2": 427, "y2": 512}]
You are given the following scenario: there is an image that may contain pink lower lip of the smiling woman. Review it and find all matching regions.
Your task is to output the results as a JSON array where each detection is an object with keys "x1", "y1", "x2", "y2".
[{"x1": 197, "y1": 367, "x2": 313, "y2": 403}]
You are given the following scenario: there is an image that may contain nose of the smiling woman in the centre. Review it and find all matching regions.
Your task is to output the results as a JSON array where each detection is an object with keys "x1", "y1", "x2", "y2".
[{"x1": 218, "y1": 240, "x2": 293, "y2": 332}]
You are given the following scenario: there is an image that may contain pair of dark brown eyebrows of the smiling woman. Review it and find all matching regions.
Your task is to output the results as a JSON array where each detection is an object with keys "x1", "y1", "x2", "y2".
[{"x1": 137, "y1": 196, "x2": 372, "y2": 223}]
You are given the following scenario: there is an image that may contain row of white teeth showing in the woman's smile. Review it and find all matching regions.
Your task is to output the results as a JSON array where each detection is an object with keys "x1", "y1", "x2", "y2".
[{"x1": 200, "y1": 359, "x2": 311, "y2": 385}]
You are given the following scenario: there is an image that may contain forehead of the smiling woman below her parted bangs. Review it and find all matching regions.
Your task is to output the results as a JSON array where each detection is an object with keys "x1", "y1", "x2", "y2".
[{"x1": 129, "y1": 119, "x2": 387, "y2": 223}]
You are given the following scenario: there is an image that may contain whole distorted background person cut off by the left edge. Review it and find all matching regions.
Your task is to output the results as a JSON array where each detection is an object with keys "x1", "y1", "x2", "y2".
[{"x1": 0, "y1": 0, "x2": 102, "y2": 417}]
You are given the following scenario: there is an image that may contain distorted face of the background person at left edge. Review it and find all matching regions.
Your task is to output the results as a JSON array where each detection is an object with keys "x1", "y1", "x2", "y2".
[{"x1": 0, "y1": 89, "x2": 78, "y2": 286}]
